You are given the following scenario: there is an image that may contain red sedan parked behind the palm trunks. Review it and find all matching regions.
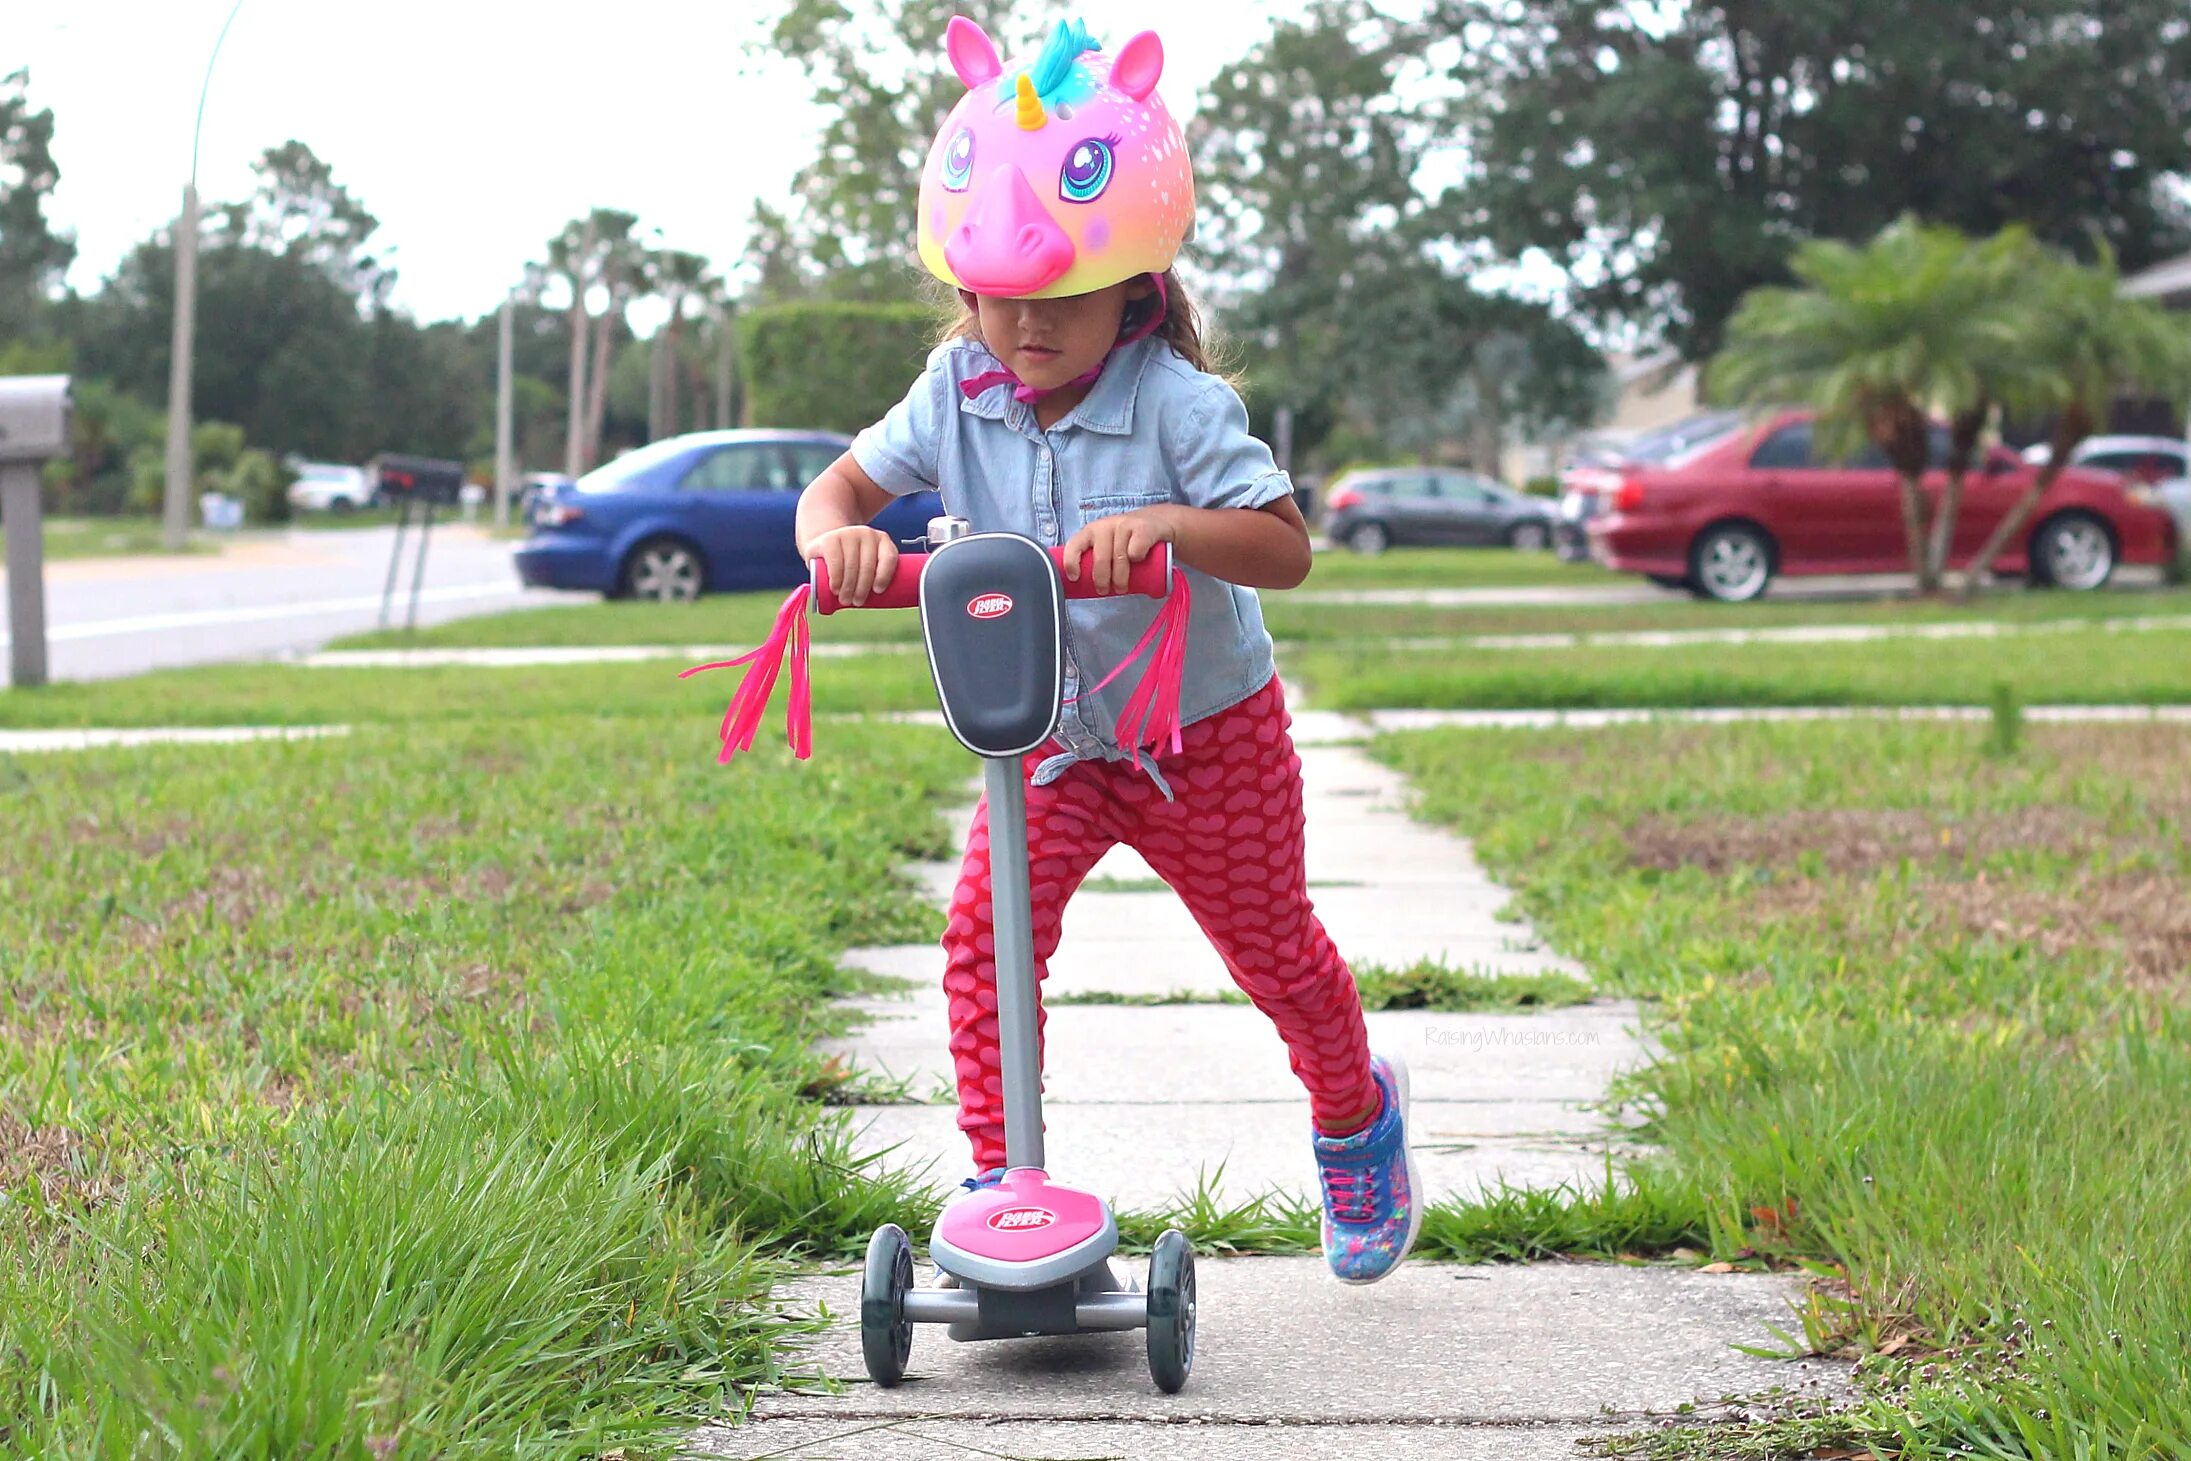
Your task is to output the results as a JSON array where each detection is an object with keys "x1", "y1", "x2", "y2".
[{"x1": 1569, "y1": 412, "x2": 2176, "y2": 602}]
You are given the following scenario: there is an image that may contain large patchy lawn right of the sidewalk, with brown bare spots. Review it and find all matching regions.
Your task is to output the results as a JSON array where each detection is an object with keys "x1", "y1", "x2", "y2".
[{"x1": 1376, "y1": 723, "x2": 2191, "y2": 1459}]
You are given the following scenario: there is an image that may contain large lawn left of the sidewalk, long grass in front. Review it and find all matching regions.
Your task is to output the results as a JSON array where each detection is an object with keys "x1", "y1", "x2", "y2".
[{"x1": 0, "y1": 709, "x2": 962, "y2": 1459}]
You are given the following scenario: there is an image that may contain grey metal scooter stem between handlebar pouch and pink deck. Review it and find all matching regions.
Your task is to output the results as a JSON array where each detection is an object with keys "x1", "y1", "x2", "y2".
[{"x1": 982, "y1": 756, "x2": 1043, "y2": 1167}]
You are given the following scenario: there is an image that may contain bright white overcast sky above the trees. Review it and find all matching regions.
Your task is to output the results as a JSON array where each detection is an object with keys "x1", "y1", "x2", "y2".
[{"x1": 21, "y1": 0, "x2": 1349, "y2": 320}]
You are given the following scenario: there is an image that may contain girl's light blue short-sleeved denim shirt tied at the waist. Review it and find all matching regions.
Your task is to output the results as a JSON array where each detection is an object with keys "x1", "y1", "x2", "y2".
[{"x1": 852, "y1": 337, "x2": 1293, "y2": 797}]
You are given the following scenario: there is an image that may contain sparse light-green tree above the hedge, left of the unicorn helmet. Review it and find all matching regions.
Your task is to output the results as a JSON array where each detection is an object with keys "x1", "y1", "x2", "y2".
[{"x1": 756, "y1": 0, "x2": 1036, "y2": 300}]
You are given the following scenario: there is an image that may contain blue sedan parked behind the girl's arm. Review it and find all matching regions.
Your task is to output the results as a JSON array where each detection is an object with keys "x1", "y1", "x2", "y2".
[{"x1": 517, "y1": 432, "x2": 942, "y2": 600}]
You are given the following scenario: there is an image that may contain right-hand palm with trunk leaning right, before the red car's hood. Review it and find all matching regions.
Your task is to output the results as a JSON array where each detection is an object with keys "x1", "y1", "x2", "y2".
[{"x1": 1959, "y1": 243, "x2": 2191, "y2": 594}]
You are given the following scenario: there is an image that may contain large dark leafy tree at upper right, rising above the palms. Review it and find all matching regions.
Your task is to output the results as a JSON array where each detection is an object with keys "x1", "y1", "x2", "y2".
[{"x1": 1433, "y1": 0, "x2": 2191, "y2": 359}]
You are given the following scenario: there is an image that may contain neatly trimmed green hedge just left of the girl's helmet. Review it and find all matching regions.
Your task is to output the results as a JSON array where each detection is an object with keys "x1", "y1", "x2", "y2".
[{"x1": 738, "y1": 300, "x2": 938, "y2": 432}]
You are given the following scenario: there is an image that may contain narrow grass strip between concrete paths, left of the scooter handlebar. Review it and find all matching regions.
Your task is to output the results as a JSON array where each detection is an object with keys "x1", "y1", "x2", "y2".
[{"x1": 0, "y1": 655, "x2": 936, "y2": 731}]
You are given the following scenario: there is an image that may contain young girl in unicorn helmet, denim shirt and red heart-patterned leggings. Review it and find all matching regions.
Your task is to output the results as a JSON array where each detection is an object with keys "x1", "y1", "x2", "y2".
[{"x1": 798, "y1": 18, "x2": 1422, "y2": 1284}]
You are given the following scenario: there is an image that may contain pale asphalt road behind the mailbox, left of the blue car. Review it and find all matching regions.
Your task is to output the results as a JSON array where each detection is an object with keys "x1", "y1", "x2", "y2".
[{"x1": 0, "y1": 524, "x2": 570, "y2": 679}]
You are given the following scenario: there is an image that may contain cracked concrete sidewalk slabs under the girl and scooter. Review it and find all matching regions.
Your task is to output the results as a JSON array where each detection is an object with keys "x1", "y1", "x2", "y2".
[{"x1": 695, "y1": 735, "x2": 1843, "y2": 1461}]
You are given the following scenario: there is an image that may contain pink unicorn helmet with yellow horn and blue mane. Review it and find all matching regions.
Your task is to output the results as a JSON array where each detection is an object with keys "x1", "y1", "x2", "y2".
[{"x1": 920, "y1": 15, "x2": 1194, "y2": 300}]
